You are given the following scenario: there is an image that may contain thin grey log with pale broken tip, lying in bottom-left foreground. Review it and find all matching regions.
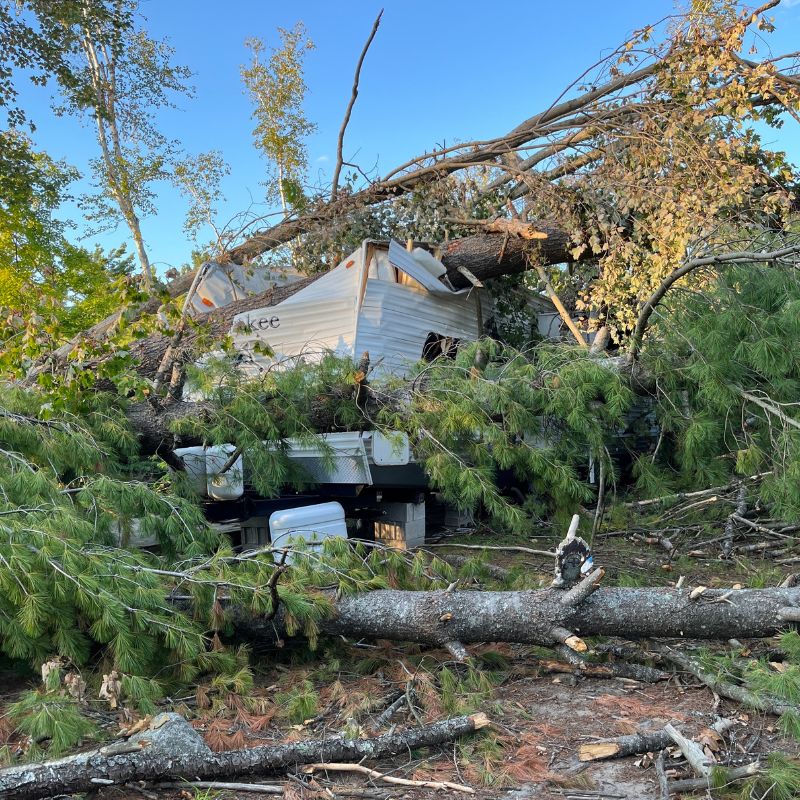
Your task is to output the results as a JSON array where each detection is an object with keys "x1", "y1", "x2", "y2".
[{"x1": 0, "y1": 714, "x2": 490, "y2": 800}]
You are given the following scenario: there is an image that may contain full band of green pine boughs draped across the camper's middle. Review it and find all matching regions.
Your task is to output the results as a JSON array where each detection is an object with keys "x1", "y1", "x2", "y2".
[{"x1": 180, "y1": 339, "x2": 632, "y2": 530}]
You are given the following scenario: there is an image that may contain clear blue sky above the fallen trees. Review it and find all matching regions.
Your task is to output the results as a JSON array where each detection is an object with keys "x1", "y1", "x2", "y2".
[{"x1": 15, "y1": 0, "x2": 800, "y2": 271}]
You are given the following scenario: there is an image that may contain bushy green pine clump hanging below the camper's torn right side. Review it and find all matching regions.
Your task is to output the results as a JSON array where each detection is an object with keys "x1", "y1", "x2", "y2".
[{"x1": 380, "y1": 340, "x2": 632, "y2": 529}]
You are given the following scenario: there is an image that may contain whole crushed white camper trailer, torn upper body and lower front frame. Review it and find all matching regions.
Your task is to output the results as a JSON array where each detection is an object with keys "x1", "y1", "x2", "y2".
[{"x1": 181, "y1": 240, "x2": 559, "y2": 547}]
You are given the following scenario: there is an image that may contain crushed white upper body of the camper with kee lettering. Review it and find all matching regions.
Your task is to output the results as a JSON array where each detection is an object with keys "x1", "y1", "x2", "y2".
[{"x1": 194, "y1": 240, "x2": 559, "y2": 382}]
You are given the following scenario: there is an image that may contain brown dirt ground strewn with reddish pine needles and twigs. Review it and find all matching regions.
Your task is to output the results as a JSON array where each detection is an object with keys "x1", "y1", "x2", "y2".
[{"x1": 0, "y1": 532, "x2": 798, "y2": 800}]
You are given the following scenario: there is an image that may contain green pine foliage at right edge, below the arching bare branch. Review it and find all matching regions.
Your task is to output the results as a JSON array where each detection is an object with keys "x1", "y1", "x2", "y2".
[{"x1": 638, "y1": 260, "x2": 800, "y2": 518}]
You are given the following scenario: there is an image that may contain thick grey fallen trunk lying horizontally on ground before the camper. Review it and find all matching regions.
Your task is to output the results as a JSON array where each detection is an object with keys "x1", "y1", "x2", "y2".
[{"x1": 235, "y1": 573, "x2": 800, "y2": 650}]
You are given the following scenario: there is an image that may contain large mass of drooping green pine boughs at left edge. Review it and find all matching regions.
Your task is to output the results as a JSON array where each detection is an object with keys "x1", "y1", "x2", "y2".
[{"x1": 0, "y1": 390, "x2": 217, "y2": 674}]
